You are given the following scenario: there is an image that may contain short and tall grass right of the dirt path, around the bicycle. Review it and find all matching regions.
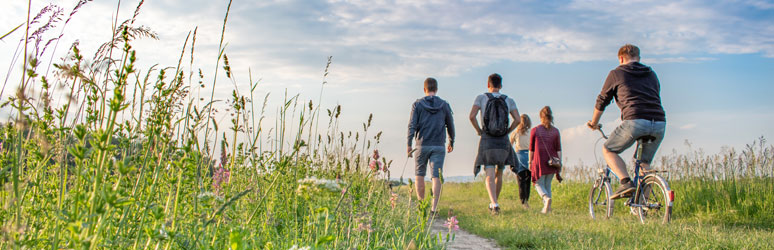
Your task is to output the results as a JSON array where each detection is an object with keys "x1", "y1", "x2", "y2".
[{"x1": 440, "y1": 139, "x2": 774, "y2": 249}]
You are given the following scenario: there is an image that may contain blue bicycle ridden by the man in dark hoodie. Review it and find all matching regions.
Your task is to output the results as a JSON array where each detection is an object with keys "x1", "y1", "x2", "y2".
[{"x1": 589, "y1": 127, "x2": 675, "y2": 224}]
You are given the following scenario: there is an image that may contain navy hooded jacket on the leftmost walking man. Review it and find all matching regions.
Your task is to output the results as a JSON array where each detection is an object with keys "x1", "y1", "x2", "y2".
[{"x1": 408, "y1": 96, "x2": 454, "y2": 147}]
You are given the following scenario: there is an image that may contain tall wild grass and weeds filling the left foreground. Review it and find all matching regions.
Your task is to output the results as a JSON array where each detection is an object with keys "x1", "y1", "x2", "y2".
[{"x1": 0, "y1": 1, "x2": 443, "y2": 249}]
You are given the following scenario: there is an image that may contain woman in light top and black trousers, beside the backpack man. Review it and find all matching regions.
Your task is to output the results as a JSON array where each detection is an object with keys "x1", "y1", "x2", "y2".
[{"x1": 511, "y1": 114, "x2": 532, "y2": 208}]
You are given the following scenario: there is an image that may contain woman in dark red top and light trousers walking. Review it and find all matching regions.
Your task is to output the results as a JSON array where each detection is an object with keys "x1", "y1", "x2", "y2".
[{"x1": 529, "y1": 106, "x2": 562, "y2": 214}]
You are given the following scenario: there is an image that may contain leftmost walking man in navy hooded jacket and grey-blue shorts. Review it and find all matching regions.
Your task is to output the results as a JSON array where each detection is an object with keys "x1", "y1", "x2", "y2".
[{"x1": 406, "y1": 78, "x2": 454, "y2": 214}]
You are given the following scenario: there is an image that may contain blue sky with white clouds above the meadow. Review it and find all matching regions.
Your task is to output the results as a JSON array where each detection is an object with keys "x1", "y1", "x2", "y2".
[{"x1": 0, "y1": 0, "x2": 774, "y2": 176}]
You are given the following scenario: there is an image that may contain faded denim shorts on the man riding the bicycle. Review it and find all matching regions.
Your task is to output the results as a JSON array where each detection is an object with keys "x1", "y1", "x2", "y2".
[{"x1": 605, "y1": 119, "x2": 666, "y2": 163}]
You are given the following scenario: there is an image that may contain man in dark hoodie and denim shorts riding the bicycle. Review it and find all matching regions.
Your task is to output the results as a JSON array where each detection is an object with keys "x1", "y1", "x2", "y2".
[{"x1": 586, "y1": 44, "x2": 666, "y2": 199}]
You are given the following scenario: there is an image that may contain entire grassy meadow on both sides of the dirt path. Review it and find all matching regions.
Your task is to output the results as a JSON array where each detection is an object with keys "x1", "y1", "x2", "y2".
[{"x1": 0, "y1": 1, "x2": 774, "y2": 249}]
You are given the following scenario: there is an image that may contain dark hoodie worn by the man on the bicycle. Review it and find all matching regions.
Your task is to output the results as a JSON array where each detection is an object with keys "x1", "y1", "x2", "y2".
[{"x1": 596, "y1": 62, "x2": 666, "y2": 121}]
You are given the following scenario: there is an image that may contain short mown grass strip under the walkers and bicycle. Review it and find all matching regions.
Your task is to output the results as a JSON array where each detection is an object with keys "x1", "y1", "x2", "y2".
[{"x1": 440, "y1": 182, "x2": 774, "y2": 249}]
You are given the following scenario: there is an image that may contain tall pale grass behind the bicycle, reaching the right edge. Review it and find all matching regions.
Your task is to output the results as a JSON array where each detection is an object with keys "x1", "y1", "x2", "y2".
[{"x1": 563, "y1": 138, "x2": 774, "y2": 227}]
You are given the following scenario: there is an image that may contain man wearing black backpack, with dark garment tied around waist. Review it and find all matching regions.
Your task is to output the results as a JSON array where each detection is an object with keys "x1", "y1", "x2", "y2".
[{"x1": 470, "y1": 73, "x2": 520, "y2": 215}]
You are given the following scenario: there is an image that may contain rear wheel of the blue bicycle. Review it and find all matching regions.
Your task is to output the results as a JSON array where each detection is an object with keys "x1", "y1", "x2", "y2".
[{"x1": 634, "y1": 175, "x2": 672, "y2": 224}]
